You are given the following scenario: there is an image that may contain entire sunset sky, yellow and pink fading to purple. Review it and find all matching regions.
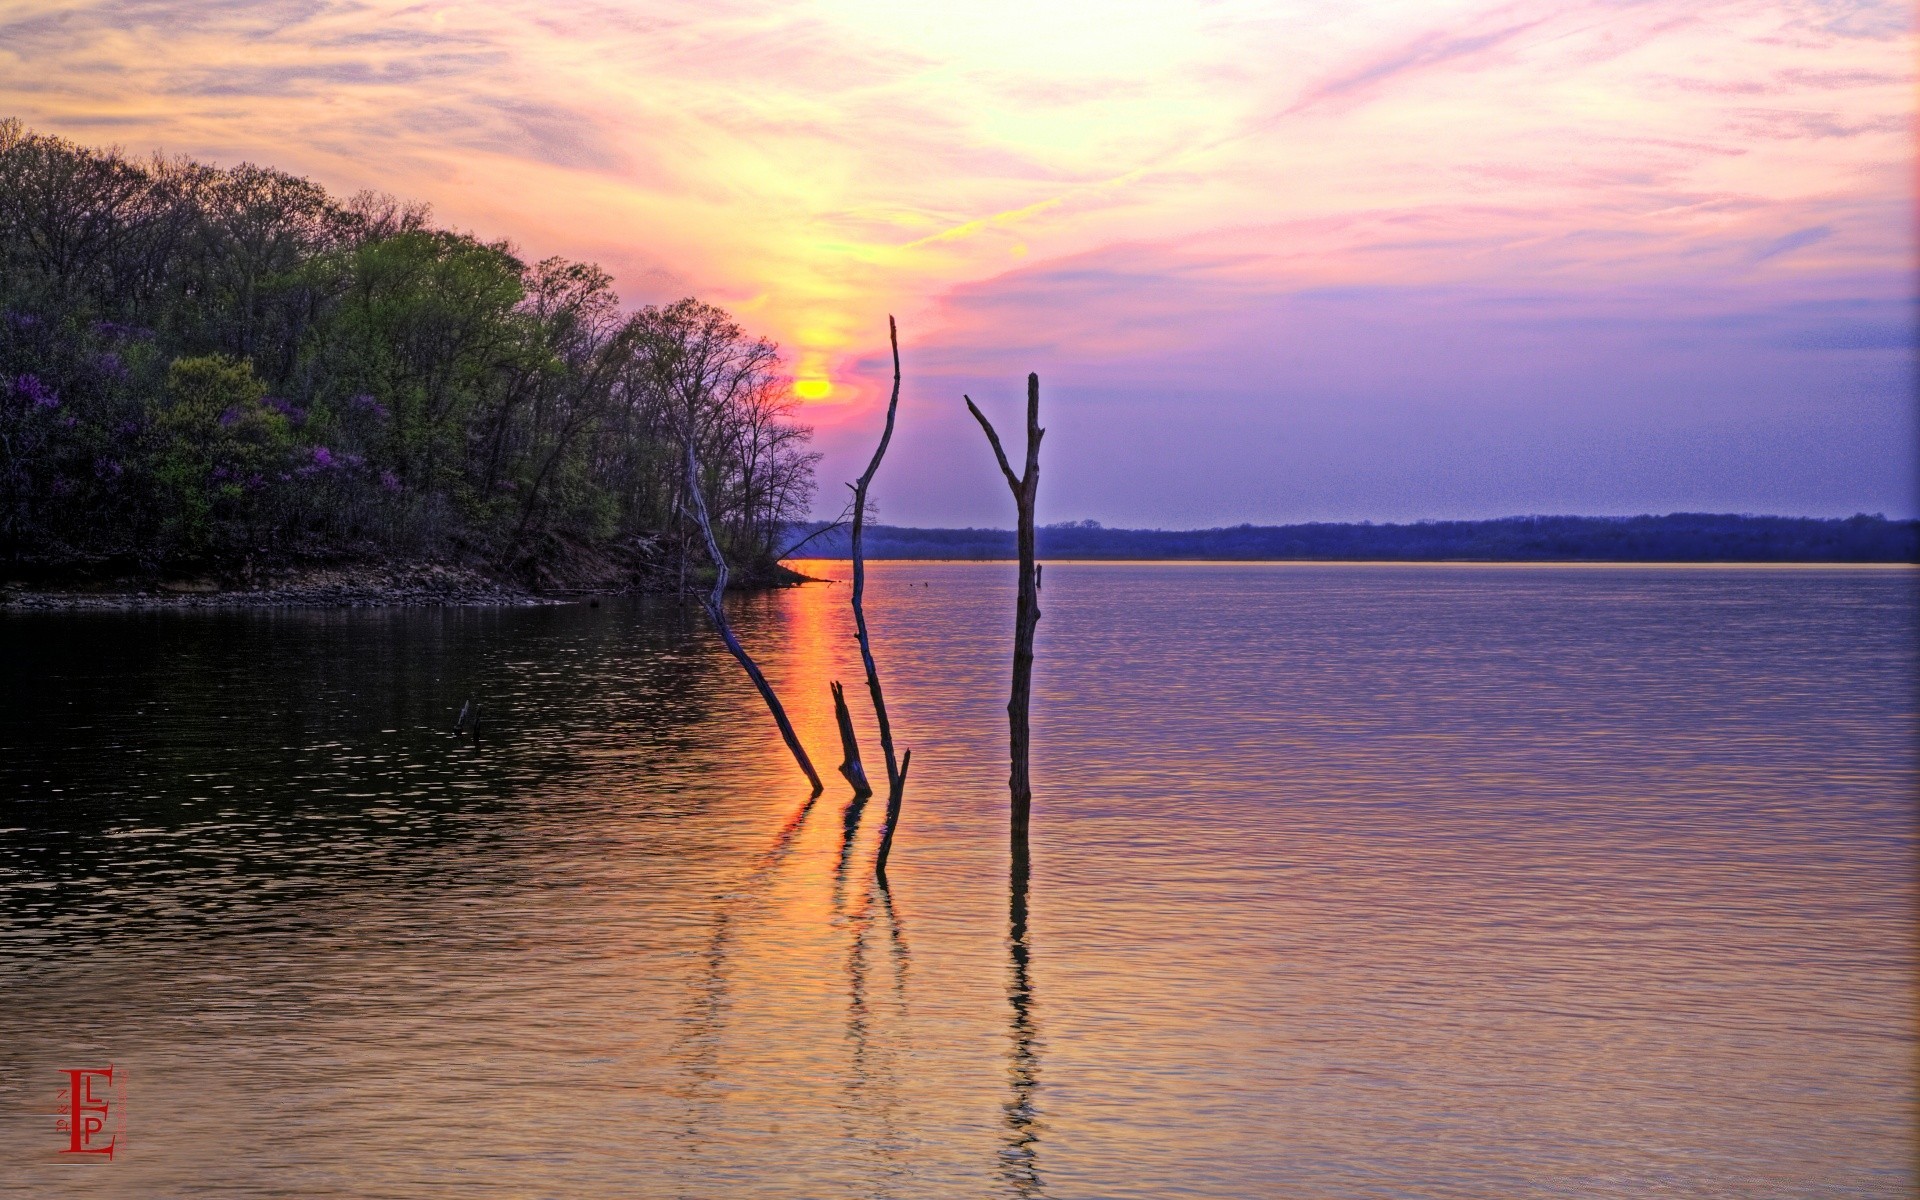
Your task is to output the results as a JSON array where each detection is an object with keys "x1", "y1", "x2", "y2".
[{"x1": 0, "y1": 0, "x2": 1916, "y2": 526}]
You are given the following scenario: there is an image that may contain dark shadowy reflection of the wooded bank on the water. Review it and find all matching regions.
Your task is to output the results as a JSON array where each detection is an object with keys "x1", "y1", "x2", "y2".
[{"x1": 0, "y1": 599, "x2": 735, "y2": 950}]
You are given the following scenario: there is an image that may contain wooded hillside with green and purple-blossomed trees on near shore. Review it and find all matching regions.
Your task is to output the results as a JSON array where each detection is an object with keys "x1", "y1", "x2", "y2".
[{"x1": 0, "y1": 121, "x2": 818, "y2": 572}]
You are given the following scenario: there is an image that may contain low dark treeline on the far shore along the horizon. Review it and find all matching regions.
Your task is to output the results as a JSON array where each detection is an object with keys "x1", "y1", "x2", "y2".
[{"x1": 791, "y1": 513, "x2": 1920, "y2": 563}]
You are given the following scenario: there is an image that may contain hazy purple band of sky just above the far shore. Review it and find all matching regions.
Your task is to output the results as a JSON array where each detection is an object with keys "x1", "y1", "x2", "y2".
[{"x1": 860, "y1": 261, "x2": 1920, "y2": 528}]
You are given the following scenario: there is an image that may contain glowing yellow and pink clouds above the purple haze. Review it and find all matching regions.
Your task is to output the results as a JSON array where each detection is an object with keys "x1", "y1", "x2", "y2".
[{"x1": 0, "y1": 0, "x2": 1914, "y2": 518}]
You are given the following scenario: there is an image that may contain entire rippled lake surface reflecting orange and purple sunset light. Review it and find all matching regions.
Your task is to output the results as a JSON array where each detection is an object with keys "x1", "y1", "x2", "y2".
[{"x1": 0, "y1": 563, "x2": 1916, "y2": 1200}]
